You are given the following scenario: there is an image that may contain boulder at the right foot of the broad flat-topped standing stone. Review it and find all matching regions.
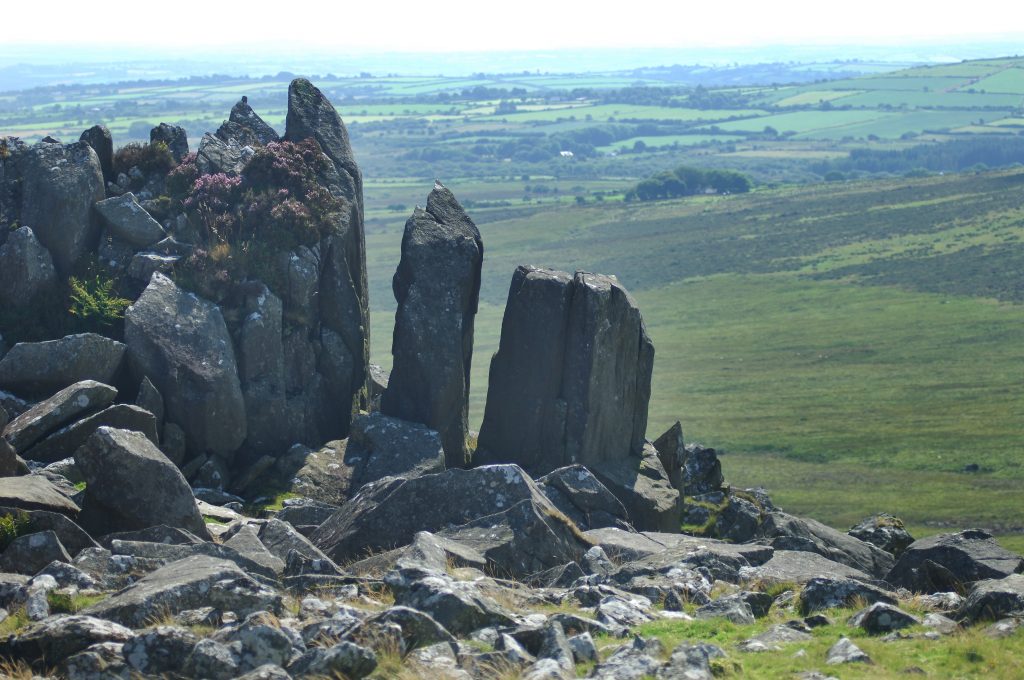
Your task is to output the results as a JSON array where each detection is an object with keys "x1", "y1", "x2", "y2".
[{"x1": 592, "y1": 443, "x2": 683, "y2": 534}]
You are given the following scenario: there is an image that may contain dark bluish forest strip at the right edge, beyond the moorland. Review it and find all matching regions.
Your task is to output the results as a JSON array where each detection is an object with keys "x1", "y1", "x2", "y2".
[{"x1": 811, "y1": 135, "x2": 1024, "y2": 179}]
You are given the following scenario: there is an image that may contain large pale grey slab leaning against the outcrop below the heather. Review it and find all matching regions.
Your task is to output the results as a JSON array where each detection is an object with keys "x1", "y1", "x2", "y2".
[{"x1": 125, "y1": 273, "x2": 247, "y2": 455}]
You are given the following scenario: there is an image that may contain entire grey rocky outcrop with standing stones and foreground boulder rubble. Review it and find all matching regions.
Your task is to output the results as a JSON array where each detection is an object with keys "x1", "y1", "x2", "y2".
[{"x1": 0, "y1": 79, "x2": 1024, "y2": 680}]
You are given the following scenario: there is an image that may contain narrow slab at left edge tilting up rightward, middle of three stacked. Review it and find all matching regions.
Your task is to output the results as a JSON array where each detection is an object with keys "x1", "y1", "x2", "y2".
[{"x1": 3, "y1": 380, "x2": 118, "y2": 453}]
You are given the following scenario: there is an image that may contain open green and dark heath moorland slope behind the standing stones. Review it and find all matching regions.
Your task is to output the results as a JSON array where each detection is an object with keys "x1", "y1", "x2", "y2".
[{"x1": 368, "y1": 170, "x2": 1024, "y2": 549}]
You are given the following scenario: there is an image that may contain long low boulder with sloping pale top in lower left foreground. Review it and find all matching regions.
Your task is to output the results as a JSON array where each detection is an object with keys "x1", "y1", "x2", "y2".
[{"x1": 82, "y1": 556, "x2": 282, "y2": 628}]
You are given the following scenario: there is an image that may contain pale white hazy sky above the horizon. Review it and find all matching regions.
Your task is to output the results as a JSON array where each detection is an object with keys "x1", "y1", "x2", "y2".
[{"x1": 8, "y1": 0, "x2": 1024, "y2": 51}]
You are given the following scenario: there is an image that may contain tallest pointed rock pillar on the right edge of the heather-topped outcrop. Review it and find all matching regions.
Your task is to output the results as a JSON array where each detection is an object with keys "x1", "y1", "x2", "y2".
[{"x1": 285, "y1": 78, "x2": 370, "y2": 437}]
